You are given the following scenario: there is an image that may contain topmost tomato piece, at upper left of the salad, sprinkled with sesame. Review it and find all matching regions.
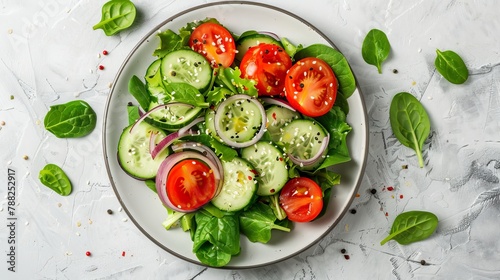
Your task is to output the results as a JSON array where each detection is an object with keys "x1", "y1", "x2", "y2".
[{"x1": 189, "y1": 22, "x2": 236, "y2": 68}]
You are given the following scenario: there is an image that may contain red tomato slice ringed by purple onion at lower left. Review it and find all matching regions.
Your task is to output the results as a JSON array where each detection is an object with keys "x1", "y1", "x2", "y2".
[{"x1": 166, "y1": 159, "x2": 216, "y2": 210}]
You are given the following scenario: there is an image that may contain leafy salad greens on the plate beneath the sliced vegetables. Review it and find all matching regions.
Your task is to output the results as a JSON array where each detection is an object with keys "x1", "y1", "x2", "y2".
[{"x1": 122, "y1": 18, "x2": 356, "y2": 267}]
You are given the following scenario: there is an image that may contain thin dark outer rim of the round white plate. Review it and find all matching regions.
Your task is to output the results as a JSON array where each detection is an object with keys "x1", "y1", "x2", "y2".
[{"x1": 101, "y1": 1, "x2": 369, "y2": 269}]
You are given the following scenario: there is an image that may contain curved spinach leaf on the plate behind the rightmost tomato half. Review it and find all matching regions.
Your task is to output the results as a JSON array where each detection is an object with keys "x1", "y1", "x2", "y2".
[{"x1": 294, "y1": 44, "x2": 356, "y2": 98}]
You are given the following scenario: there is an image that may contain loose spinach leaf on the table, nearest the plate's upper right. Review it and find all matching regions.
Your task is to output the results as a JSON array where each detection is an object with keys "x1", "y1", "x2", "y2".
[{"x1": 361, "y1": 29, "x2": 391, "y2": 74}]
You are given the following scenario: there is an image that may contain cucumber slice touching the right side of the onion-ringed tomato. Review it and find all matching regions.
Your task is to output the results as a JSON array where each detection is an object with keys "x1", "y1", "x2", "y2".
[{"x1": 212, "y1": 157, "x2": 257, "y2": 212}]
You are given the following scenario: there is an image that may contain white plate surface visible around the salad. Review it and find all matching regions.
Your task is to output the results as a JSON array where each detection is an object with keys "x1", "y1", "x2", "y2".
[{"x1": 103, "y1": 2, "x2": 368, "y2": 268}]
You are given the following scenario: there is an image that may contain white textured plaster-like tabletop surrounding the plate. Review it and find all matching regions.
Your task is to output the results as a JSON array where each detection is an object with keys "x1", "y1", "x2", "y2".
[{"x1": 0, "y1": 0, "x2": 500, "y2": 279}]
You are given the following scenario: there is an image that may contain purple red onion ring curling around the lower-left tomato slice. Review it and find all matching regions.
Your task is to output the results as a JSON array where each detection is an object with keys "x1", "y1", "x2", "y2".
[{"x1": 156, "y1": 151, "x2": 222, "y2": 213}]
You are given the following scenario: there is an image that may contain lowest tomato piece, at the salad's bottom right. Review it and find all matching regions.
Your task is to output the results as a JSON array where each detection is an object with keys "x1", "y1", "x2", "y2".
[{"x1": 279, "y1": 177, "x2": 323, "y2": 222}]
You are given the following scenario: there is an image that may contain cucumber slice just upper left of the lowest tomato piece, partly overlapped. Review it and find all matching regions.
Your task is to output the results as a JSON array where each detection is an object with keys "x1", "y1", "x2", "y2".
[{"x1": 241, "y1": 141, "x2": 288, "y2": 196}]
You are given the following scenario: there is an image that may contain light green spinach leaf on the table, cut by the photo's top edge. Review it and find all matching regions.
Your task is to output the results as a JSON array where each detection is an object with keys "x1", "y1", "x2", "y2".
[{"x1": 93, "y1": 0, "x2": 137, "y2": 36}]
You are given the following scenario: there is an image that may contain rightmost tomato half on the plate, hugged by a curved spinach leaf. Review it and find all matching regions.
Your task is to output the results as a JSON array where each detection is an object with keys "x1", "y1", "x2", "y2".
[{"x1": 285, "y1": 57, "x2": 338, "y2": 117}]
